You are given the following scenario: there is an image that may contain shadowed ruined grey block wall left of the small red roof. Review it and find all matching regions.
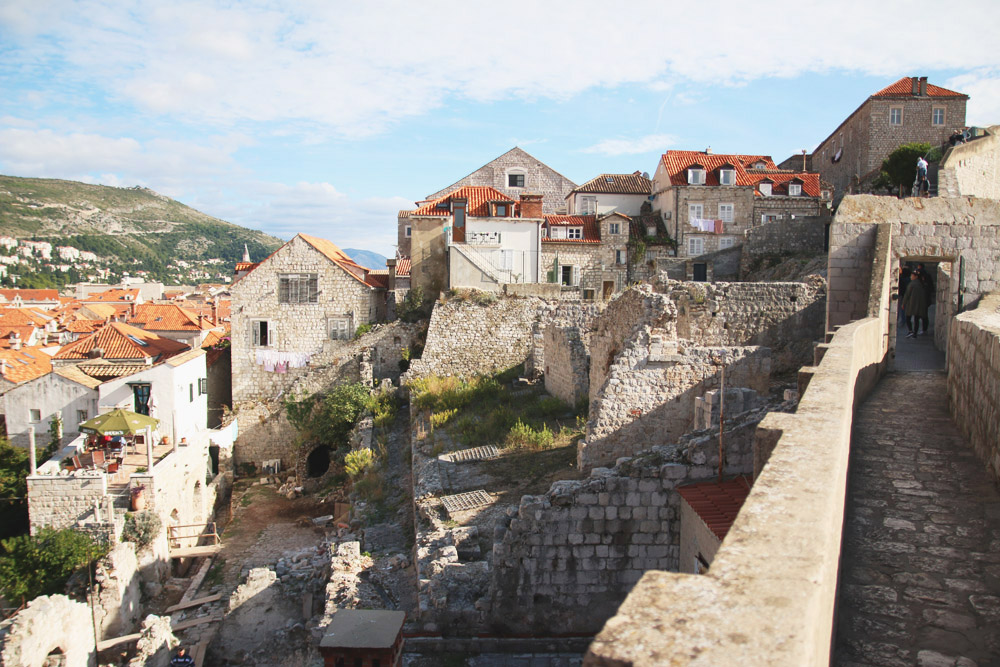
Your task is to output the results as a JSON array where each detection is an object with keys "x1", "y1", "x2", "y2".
[{"x1": 489, "y1": 414, "x2": 761, "y2": 634}]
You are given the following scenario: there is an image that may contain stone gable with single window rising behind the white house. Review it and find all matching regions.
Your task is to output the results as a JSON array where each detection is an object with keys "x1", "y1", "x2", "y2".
[{"x1": 421, "y1": 146, "x2": 576, "y2": 214}]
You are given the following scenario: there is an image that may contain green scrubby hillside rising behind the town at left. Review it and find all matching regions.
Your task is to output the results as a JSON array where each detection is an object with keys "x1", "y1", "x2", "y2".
[{"x1": 0, "y1": 176, "x2": 283, "y2": 278}]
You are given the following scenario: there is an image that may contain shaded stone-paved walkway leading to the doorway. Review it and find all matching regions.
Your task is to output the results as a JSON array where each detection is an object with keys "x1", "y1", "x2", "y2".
[{"x1": 833, "y1": 374, "x2": 1000, "y2": 667}]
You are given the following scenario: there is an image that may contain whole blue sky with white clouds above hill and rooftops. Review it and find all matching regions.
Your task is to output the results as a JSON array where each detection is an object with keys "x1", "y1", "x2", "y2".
[{"x1": 0, "y1": 0, "x2": 1000, "y2": 255}]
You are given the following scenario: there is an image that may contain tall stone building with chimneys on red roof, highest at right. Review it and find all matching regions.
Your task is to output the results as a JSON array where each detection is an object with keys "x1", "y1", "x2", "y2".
[{"x1": 796, "y1": 76, "x2": 969, "y2": 203}]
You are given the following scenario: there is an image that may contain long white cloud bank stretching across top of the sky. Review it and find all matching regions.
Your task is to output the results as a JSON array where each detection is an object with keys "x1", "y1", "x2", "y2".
[{"x1": 0, "y1": 0, "x2": 1000, "y2": 136}]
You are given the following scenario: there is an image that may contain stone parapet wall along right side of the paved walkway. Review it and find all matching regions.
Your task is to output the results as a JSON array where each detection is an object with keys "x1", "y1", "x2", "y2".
[{"x1": 948, "y1": 294, "x2": 1000, "y2": 480}]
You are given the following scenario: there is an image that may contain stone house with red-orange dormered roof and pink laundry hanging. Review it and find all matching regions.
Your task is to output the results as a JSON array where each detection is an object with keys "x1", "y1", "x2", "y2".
[{"x1": 652, "y1": 149, "x2": 823, "y2": 264}]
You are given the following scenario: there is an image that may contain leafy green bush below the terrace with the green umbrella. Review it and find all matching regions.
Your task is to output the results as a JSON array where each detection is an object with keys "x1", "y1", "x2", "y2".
[{"x1": 0, "y1": 528, "x2": 108, "y2": 600}]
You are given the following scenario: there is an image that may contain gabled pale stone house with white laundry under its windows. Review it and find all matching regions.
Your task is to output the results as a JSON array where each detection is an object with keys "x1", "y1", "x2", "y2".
[{"x1": 232, "y1": 234, "x2": 385, "y2": 404}]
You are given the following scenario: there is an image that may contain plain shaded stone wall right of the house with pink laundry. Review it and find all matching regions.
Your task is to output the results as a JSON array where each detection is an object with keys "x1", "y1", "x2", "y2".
[{"x1": 740, "y1": 216, "x2": 830, "y2": 276}]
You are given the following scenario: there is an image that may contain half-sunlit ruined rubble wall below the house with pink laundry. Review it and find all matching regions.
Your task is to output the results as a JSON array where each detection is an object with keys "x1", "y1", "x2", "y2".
[{"x1": 663, "y1": 280, "x2": 826, "y2": 373}]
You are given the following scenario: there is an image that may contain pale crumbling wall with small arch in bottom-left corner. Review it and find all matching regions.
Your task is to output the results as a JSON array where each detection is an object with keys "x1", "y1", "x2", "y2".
[{"x1": 0, "y1": 595, "x2": 97, "y2": 667}]
